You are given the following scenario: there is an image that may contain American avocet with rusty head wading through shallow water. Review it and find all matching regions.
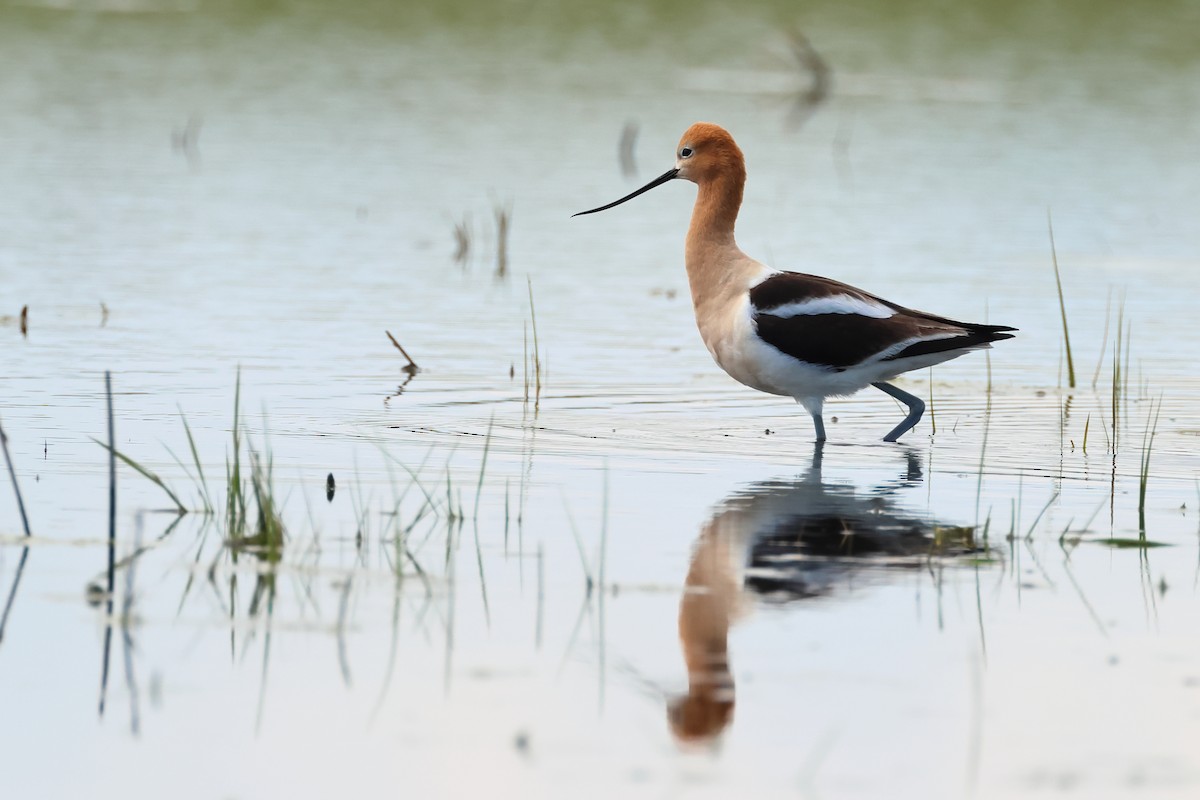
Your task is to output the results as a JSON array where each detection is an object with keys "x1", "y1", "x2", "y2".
[{"x1": 575, "y1": 122, "x2": 1016, "y2": 441}]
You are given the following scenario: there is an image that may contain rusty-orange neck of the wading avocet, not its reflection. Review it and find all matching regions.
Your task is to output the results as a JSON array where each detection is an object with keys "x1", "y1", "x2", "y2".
[{"x1": 686, "y1": 170, "x2": 745, "y2": 315}]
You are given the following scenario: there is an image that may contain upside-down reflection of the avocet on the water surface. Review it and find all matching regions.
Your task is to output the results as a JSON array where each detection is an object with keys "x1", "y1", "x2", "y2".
[{"x1": 667, "y1": 443, "x2": 977, "y2": 742}]
